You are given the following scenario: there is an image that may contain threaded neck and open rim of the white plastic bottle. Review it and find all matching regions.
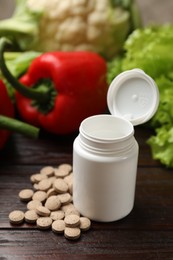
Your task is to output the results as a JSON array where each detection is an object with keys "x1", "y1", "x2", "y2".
[{"x1": 79, "y1": 115, "x2": 135, "y2": 154}]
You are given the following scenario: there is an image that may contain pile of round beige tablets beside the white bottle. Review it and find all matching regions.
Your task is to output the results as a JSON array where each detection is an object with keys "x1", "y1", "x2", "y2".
[{"x1": 9, "y1": 164, "x2": 91, "y2": 240}]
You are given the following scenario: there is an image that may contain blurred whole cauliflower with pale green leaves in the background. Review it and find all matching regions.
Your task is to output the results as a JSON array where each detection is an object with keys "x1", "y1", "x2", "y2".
[{"x1": 0, "y1": 0, "x2": 140, "y2": 58}]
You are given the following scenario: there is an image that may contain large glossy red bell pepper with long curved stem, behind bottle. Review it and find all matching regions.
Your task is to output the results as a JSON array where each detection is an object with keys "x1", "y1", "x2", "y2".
[{"x1": 0, "y1": 38, "x2": 108, "y2": 134}]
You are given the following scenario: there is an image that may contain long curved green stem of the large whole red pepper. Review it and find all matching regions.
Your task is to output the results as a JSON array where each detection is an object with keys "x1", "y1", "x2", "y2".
[{"x1": 0, "y1": 37, "x2": 50, "y2": 103}]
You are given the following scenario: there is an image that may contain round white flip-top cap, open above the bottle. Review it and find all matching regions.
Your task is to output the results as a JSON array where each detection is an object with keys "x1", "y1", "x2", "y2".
[{"x1": 107, "y1": 69, "x2": 159, "y2": 126}]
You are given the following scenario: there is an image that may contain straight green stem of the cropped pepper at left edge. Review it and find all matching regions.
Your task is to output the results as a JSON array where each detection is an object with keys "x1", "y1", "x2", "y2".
[{"x1": 0, "y1": 115, "x2": 39, "y2": 139}]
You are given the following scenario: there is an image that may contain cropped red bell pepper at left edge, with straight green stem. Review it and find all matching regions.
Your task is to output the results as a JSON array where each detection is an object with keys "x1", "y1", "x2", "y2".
[{"x1": 0, "y1": 80, "x2": 39, "y2": 150}]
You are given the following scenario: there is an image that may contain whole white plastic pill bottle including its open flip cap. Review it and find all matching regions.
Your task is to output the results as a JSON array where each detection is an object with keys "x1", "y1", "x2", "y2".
[{"x1": 73, "y1": 69, "x2": 159, "y2": 222}]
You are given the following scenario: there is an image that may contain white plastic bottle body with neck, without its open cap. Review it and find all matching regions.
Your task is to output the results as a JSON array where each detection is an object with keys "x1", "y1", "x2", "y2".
[{"x1": 73, "y1": 115, "x2": 138, "y2": 222}]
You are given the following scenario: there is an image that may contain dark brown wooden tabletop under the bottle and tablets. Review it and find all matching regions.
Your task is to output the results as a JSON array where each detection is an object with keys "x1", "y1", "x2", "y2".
[{"x1": 0, "y1": 127, "x2": 173, "y2": 260}]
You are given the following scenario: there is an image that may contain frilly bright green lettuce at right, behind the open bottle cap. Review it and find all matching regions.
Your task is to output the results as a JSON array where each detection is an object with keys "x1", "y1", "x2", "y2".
[{"x1": 108, "y1": 25, "x2": 173, "y2": 167}]
